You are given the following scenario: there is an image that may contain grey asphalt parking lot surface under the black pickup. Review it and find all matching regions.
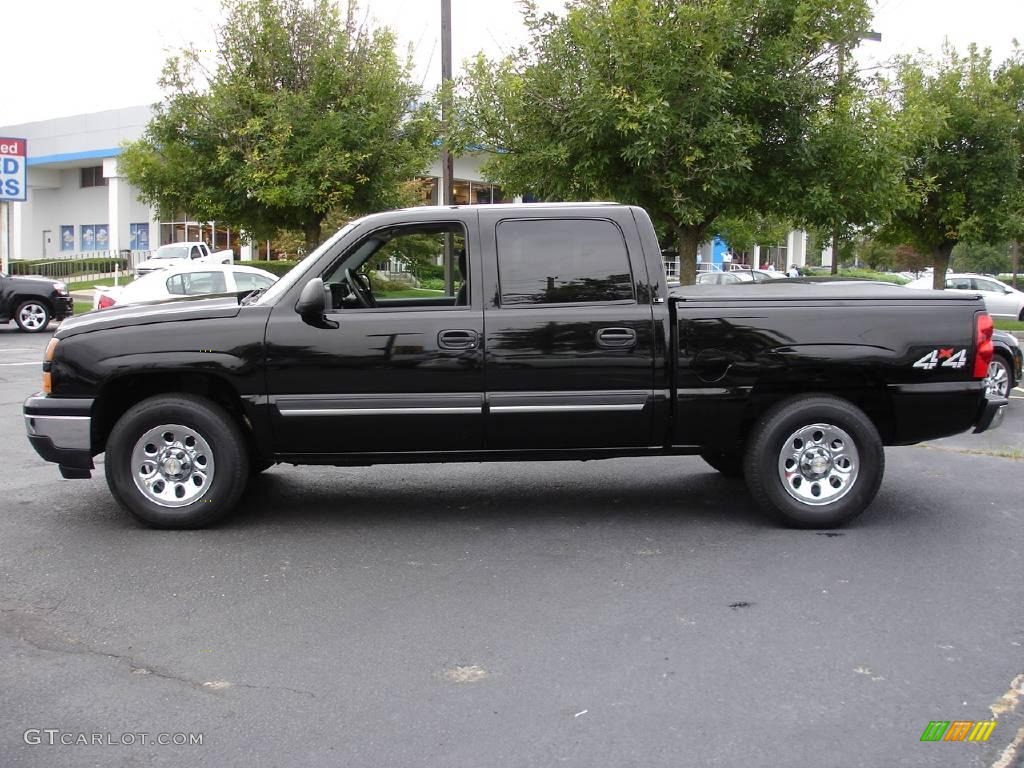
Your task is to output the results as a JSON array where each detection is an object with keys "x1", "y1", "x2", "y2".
[{"x1": 0, "y1": 327, "x2": 1024, "y2": 768}]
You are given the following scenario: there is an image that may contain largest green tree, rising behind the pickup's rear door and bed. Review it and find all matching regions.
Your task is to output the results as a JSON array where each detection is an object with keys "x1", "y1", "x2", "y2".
[{"x1": 449, "y1": 0, "x2": 869, "y2": 282}]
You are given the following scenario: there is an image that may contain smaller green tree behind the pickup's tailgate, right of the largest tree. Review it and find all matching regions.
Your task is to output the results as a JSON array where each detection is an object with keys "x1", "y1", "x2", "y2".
[{"x1": 882, "y1": 46, "x2": 1021, "y2": 289}]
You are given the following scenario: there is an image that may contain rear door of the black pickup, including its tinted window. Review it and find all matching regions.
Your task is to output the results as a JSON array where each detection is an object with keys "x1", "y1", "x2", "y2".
[{"x1": 479, "y1": 207, "x2": 654, "y2": 451}]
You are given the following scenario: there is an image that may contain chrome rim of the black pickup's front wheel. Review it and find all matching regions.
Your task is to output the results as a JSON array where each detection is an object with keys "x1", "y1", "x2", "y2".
[{"x1": 131, "y1": 424, "x2": 215, "y2": 508}]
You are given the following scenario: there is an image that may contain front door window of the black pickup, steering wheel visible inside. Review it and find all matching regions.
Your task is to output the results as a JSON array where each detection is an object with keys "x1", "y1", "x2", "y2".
[{"x1": 324, "y1": 222, "x2": 469, "y2": 309}]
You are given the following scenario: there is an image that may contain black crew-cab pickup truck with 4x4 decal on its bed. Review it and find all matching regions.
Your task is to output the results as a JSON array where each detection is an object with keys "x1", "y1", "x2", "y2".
[{"x1": 24, "y1": 204, "x2": 1007, "y2": 527}]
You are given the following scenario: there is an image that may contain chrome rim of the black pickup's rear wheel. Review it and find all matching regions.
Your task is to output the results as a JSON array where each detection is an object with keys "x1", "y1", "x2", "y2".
[{"x1": 778, "y1": 424, "x2": 860, "y2": 507}]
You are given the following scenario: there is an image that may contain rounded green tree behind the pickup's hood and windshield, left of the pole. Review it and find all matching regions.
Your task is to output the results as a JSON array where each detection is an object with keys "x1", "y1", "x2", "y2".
[{"x1": 120, "y1": 0, "x2": 437, "y2": 250}]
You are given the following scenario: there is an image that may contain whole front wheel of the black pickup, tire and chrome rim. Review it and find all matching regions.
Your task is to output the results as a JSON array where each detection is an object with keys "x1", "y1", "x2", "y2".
[{"x1": 104, "y1": 394, "x2": 249, "y2": 528}]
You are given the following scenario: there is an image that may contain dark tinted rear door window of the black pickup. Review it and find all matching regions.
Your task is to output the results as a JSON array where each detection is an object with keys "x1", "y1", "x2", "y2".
[{"x1": 498, "y1": 219, "x2": 636, "y2": 306}]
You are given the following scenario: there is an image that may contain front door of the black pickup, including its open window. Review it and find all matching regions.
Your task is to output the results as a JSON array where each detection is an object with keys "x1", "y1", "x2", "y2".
[{"x1": 266, "y1": 210, "x2": 483, "y2": 456}]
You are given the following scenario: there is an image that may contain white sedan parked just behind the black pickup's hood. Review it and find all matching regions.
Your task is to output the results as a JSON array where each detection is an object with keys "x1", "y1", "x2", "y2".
[{"x1": 92, "y1": 263, "x2": 278, "y2": 309}]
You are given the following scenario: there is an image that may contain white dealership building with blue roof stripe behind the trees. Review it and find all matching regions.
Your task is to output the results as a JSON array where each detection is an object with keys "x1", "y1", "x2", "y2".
[{"x1": 0, "y1": 105, "x2": 807, "y2": 274}]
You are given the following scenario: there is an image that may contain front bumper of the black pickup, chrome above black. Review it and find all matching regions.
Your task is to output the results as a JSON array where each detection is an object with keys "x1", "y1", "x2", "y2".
[{"x1": 22, "y1": 394, "x2": 95, "y2": 478}]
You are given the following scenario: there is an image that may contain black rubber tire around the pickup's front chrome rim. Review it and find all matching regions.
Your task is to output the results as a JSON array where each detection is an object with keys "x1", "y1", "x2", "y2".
[{"x1": 104, "y1": 394, "x2": 249, "y2": 528}]
